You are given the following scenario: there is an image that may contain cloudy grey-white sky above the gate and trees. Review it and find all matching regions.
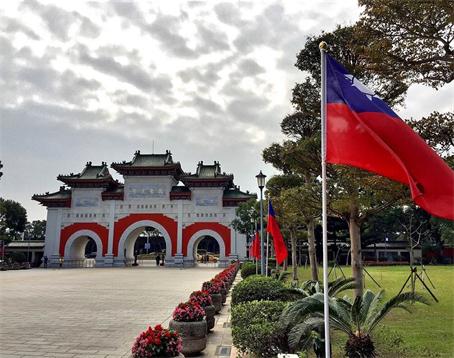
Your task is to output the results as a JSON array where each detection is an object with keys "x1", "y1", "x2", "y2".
[{"x1": 0, "y1": 0, "x2": 454, "y2": 220}]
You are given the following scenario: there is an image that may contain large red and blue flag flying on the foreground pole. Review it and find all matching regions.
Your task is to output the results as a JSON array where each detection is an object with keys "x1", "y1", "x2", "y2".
[{"x1": 326, "y1": 55, "x2": 454, "y2": 220}]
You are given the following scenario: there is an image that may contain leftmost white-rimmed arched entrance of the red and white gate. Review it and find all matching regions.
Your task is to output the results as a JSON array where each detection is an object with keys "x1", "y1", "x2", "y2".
[{"x1": 62, "y1": 230, "x2": 103, "y2": 267}]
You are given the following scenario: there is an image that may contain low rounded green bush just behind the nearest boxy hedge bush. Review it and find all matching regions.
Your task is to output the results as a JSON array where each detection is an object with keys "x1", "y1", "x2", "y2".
[{"x1": 232, "y1": 275, "x2": 284, "y2": 305}]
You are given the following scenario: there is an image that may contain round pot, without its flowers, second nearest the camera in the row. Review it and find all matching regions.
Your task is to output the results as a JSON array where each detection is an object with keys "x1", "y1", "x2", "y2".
[{"x1": 169, "y1": 320, "x2": 207, "y2": 354}]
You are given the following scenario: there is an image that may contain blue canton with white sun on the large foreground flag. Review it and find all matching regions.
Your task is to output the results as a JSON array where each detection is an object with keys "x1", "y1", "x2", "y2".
[{"x1": 326, "y1": 54, "x2": 399, "y2": 118}]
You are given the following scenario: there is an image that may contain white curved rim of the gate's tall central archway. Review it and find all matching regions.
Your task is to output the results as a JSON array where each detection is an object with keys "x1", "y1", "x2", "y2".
[{"x1": 117, "y1": 220, "x2": 172, "y2": 262}]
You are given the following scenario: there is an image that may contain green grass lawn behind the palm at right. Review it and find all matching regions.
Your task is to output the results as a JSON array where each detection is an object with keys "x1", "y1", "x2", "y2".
[{"x1": 290, "y1": 266, "x2": 454, "y2": 358}]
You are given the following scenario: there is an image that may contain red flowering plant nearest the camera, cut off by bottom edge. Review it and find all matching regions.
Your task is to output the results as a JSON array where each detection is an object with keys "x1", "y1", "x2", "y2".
[{"x1": 131, "y1": 324, "x2": 184, "y2": 358}]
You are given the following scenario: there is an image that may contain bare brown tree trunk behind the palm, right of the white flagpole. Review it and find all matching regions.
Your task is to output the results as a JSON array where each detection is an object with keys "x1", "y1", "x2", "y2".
[{"x1": 348, "y1": 204, "x2": 363, "y2": 296}]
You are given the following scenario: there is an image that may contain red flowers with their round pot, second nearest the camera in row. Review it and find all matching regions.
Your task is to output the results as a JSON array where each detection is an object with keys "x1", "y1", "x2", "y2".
[{"x1": 169, "y1": 302, "x2": 207, "y2": 354}]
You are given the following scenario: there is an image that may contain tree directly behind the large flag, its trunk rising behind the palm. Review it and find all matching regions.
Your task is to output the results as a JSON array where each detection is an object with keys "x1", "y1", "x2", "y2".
[{"x1": 293, "y1": 26, "x2": 408, "y2": 296}]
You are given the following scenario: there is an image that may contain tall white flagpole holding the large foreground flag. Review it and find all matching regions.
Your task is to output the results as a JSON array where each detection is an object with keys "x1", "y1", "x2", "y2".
[{"x1": 319, "y1": 41, "x2": 331, "y2": 358}]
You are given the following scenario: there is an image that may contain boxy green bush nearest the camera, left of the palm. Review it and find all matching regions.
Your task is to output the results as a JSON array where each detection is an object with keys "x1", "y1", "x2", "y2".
[{"x1": 232, "y1": 301, "x2": 289, "y2": 358}]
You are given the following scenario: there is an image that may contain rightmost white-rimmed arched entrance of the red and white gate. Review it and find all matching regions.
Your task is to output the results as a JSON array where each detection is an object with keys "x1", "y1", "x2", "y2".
[{"x1": 184, "y1": 230, "x2": 228, "y2": 267}]
